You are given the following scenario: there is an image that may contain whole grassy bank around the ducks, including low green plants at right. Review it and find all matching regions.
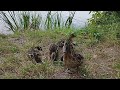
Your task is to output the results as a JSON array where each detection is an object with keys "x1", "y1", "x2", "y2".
[{"x1": 0, "y1": 25, "x2": 120, "y2": 79}]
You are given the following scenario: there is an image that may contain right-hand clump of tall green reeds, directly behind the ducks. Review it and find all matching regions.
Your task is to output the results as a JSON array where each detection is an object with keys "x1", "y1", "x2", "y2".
[{"x1": 45, "y1": 11, "x2": 75, "y2": 29}]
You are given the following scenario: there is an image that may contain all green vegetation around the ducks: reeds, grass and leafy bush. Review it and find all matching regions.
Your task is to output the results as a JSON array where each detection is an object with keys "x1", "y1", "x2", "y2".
[{"x1": 0, "y1": 11, "x2": 120, "y2": 79}]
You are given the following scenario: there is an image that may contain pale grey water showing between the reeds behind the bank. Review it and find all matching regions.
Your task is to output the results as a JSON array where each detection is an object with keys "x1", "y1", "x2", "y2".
[{"x1": 0, "y1": 11, "x2": 92, "y2": 34}]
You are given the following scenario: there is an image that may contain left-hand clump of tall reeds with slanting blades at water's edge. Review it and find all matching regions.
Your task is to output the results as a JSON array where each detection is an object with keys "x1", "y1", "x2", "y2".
[{"x1": 0, "y1": 11, "x2": 42, "y2": 32}]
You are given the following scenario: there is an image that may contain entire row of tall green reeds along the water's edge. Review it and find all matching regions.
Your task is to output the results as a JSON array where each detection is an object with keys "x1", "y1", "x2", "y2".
[{"x1": 0, "y1": 11, "x2": 75, "y2": 32}]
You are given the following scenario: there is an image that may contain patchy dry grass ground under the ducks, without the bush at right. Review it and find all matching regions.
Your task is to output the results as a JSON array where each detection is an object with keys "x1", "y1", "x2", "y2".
[{"x1": 0, "y1": 32, "x2": 120, "y2": 79}]
